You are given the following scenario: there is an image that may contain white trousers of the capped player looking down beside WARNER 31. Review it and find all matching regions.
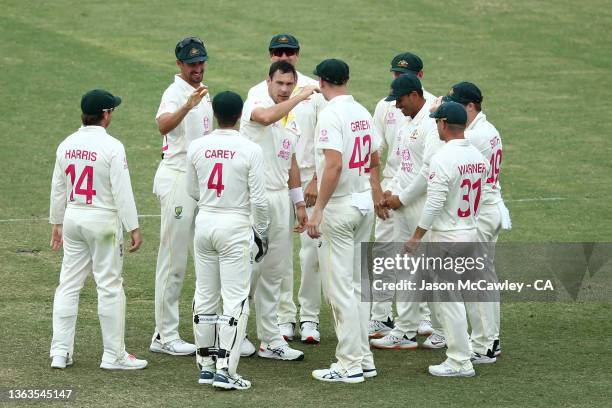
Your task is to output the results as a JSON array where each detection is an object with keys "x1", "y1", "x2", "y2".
[{"x1": 392, "y1": 196, "x2": 443, "y2": 339}]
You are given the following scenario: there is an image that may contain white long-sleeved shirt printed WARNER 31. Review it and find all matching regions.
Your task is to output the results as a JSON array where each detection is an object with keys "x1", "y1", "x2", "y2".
[{"x1": 419, "y1": 139, "x2": 489, "y2": 231}]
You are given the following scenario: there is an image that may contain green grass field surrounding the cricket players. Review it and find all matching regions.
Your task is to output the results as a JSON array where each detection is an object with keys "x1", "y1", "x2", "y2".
[{"x1": 0, "y1": 0, "x2": 612, "y2": 407}]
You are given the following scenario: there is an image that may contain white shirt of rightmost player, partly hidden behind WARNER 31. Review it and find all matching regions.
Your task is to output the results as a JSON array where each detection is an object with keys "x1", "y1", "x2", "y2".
[{"x1": 465, "y1": 112, "x2": 502, "y2": 204}]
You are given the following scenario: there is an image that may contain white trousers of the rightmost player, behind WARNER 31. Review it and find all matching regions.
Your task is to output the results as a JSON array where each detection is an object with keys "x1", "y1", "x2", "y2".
[{"x1": 465, "y1": 204, "x2": 501, "y2": 355}]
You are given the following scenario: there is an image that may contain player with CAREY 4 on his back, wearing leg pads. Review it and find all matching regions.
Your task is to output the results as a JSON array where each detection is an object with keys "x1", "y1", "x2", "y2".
[{"x1": 186, "y1": 91, "x2": 268, "y2": 390}]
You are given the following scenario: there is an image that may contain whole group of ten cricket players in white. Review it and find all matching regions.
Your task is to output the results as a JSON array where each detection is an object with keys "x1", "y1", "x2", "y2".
[{"x1": 50, "y1": 34, "x2": 511, "y2": 390}]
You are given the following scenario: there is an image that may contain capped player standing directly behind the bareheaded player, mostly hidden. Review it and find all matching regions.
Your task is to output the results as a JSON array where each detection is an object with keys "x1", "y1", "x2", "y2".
[{"x1": 249, "y1": 34, "x2": 325, "y2": 343}]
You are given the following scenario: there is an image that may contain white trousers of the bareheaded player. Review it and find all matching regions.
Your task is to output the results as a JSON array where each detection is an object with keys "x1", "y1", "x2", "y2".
[{"x1": 253, "y1": 189, "x2": 293, "y2": 348}]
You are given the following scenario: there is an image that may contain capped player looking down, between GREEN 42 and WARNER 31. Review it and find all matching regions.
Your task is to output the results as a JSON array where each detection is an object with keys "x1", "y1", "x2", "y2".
[{"x1": 371, "y1": 74, "x2": 445, "y2": 350}]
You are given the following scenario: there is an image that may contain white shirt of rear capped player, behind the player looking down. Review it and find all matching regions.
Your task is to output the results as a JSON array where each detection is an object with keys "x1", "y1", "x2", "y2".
[{"x1": 374, "y1": 89, "x2": 436, "y2": 178}]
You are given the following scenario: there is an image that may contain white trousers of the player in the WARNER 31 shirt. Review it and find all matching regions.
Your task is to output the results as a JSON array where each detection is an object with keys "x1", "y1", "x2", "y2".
[{"x1": 429, "y1": 229, "x2": 477, "y2": 370}]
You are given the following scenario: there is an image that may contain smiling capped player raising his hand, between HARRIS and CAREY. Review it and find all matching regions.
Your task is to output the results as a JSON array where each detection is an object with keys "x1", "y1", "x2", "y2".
[{"x1": 149, "y1": 37, "x2": 213, "y2": 355}]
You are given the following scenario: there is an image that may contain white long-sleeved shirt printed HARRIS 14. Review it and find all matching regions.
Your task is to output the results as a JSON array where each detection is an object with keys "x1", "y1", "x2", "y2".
[{"x1": 49, "y1": 126, "x2": 138, "y2": 231}]
